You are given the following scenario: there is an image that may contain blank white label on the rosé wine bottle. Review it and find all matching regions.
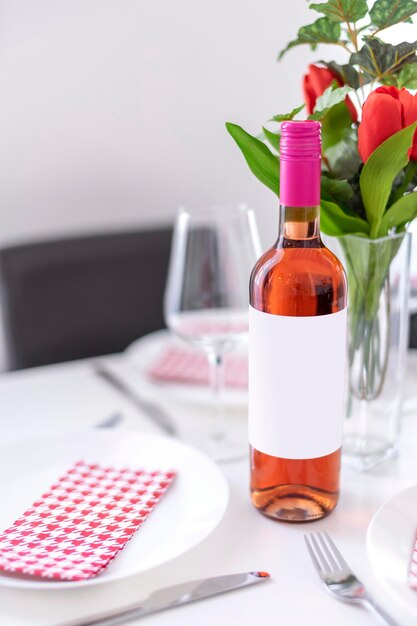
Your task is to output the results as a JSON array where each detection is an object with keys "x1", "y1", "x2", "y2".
[{"x1": 249, "y1": 307, "x2": 346, "y2": 459}]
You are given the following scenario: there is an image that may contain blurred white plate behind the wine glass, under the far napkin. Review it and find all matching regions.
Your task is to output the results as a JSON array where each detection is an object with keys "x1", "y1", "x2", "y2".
[{"x1": 125, "y1": 330, "x2": 248, "y2": 408}]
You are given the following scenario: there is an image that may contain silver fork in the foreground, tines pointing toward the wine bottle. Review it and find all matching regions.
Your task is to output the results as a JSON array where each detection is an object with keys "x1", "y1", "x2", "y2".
[{"x1": 304, "y1": 532, "x2": 399, "y2": 626}]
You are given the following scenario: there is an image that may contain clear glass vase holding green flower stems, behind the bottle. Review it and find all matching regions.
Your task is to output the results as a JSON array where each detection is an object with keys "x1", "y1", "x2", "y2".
[{"x1": 333, "y1": 232, "x2": 411, "y2": 470}]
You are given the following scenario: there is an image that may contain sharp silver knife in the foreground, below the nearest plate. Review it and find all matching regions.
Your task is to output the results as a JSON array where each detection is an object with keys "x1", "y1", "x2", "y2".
[{"x1": 61, "y1": 572, "x2": 270, "y2": 626}]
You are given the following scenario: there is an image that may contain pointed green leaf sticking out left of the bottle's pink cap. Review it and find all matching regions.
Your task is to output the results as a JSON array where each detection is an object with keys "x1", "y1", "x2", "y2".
[{"x1": 226, "y1": 122, "x2": 279, "y2": 196}]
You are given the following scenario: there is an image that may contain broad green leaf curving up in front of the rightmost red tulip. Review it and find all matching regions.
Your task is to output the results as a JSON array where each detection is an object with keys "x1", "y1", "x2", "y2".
[{"x1": 360, "y1": 122, "x2": 417, "y2": 238}]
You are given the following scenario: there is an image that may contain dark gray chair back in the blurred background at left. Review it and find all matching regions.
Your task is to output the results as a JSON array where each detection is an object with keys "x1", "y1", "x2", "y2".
[{"x1": 0, "y1": 227, "x2": 172, "y2": 369}]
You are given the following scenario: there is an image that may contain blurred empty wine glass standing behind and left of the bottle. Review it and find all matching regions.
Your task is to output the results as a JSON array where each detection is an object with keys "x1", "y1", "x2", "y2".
[{"x1": 164, "y1": 206, "x2": 260, "y2": 461}]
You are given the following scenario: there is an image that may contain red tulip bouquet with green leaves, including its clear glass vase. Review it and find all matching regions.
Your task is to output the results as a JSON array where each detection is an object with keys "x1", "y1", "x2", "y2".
[{"x1": 226, "y1": 0, "x2": 417, "y2": 468}]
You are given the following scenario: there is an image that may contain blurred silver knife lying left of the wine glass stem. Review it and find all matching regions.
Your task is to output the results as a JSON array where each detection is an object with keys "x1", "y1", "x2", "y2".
[{"x1": 94, "y1": 361, "x2": 176, "y2": 435}]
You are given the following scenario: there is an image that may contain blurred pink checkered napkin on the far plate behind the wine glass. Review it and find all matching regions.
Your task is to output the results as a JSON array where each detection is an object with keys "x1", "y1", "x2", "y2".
[{"x1": 148, "y1": 346, "x2": 248, "y2": 388}]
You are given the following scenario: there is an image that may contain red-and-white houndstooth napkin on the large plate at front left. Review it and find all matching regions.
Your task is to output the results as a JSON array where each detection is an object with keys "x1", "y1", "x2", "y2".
[{"x1": 0, "y1": 461, "x2": 175, "y2": 580}]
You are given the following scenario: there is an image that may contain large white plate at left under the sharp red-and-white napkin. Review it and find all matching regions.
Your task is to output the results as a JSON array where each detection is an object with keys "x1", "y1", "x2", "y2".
[{"x1": 0, "y1": 430, "x2": 229, "y2": 589}]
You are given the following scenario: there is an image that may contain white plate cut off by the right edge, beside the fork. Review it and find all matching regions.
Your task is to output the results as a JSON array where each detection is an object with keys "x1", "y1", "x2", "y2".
[{"x1": 367, "y1": 485, "x2": 417, "y2": 623}]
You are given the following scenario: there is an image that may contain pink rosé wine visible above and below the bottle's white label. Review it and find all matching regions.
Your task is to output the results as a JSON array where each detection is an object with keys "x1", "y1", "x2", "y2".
[{"x1": 250, "y1": 207, "x2": 347, "y2": 522}]
